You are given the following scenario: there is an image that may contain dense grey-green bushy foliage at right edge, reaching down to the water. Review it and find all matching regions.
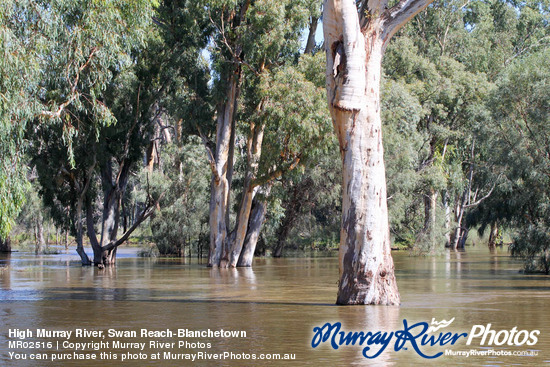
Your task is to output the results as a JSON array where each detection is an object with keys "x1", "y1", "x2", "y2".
[{"x1": 489, "y1": 49, "x2": 550, "y2": 273}]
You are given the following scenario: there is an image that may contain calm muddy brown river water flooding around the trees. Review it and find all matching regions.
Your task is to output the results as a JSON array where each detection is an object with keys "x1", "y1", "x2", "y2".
[{"x1": 0, "y1": 246, "x2": 550, "y2": 366}]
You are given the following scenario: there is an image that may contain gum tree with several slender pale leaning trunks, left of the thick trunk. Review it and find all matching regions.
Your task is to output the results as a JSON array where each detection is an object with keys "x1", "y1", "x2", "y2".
[{"x1": 203, "y1": 0, "x2": 330, "y2": 267}]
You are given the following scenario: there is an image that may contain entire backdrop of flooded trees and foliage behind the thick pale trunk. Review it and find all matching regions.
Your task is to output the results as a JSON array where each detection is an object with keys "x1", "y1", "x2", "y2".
[{"x1": 0, "y1": 0, "x2": 550, "y2": 280}]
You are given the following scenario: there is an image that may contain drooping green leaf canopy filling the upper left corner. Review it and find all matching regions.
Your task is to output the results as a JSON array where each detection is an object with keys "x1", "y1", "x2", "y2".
[{"x1": 0, "y1": 0, "x2": 152, "y2": 237}]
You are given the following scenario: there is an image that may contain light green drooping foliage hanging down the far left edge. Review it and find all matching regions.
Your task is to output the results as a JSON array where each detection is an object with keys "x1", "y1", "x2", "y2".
[{"x1": 0, "y1": 0, "x2": 42, "y2": 239}]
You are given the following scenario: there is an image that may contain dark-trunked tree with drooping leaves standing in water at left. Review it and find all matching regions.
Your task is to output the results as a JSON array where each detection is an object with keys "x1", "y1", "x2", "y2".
[{"x1": 24, "y1": 1, "x2": 158, "y2": 265}]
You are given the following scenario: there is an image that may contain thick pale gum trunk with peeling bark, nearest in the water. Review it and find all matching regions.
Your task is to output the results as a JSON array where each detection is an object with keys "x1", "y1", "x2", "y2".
[{"x1": 323, "y1": 0, "x2": 436, "y2": 305}]
